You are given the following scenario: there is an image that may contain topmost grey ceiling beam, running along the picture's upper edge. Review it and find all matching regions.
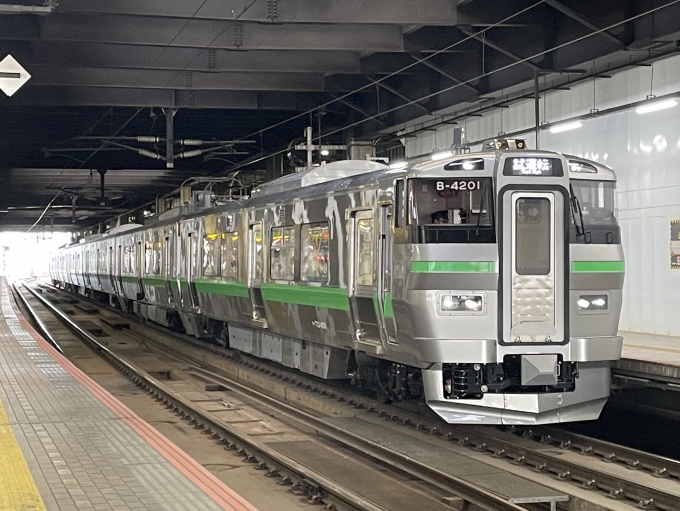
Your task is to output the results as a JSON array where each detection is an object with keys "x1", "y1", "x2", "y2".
[{"x1": 59, "y1": 0, "x2": 457, "y2": 25}]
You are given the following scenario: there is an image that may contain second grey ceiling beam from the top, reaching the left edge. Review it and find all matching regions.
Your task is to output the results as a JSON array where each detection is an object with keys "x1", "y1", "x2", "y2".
[{"x1": 0, "y1": 13, "x2": 403, "y2": 52}]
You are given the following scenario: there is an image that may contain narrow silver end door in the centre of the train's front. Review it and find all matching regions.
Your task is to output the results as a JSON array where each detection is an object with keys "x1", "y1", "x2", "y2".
[{"x1": 501, "y1": 190, "x2": 569, "y2": 344}]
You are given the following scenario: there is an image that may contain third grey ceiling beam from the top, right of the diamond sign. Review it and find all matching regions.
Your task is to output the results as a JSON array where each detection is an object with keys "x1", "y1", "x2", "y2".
[{"x1": 30, "y1": 42, "x2": 360, "y2": 73}]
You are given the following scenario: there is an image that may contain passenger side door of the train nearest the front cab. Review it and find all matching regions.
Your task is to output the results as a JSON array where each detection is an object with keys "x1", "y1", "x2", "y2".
[{"x1": 350, "y1": 209, "x2": 384, "y2": 354}]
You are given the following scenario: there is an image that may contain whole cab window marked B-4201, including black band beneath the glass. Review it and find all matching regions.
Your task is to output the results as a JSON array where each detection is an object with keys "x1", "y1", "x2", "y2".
[{"x1": 408, "y1": 177, "x2": 495, "y2": 243}]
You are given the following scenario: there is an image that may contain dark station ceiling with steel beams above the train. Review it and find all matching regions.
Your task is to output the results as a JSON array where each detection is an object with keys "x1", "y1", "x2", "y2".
[{"x1": 0, "y1": 0, "x2": 680, "y2": 231}]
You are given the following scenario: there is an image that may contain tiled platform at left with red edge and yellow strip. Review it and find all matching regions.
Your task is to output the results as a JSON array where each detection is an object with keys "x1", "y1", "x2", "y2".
[{"x1": 0, "y1": 277, "x2": 255, "y2": 511}]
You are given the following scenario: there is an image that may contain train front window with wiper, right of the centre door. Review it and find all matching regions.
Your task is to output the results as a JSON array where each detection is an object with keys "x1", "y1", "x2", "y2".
[{"x1": 570, "y1": 179, "x2": 620, "y2": 243}]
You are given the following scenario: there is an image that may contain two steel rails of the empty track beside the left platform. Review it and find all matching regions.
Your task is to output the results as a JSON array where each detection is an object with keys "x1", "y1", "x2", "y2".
[{"x1": 17, "y1": 286, "x2": 523, "y2": 511}]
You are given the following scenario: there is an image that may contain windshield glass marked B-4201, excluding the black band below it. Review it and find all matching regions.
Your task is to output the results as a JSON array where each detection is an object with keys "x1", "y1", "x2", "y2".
[{"x1": 409, "y1": 178, "x2": 492, "y2": 227}]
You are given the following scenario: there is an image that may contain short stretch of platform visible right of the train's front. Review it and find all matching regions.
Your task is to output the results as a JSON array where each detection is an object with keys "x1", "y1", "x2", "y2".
[{"x1": 613, "y1": 332, "x2": 680, "y2": 390}]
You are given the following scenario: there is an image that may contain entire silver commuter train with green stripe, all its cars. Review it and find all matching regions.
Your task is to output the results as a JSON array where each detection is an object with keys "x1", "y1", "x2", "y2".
[{"x1": 51, "y1": 144, "x2": 624, "y2": 424}]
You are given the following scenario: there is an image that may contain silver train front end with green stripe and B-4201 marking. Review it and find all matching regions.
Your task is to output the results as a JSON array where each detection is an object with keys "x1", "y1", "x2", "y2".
[{"x1": 402, "y1": 147, "x2": 623, "y2": 424}]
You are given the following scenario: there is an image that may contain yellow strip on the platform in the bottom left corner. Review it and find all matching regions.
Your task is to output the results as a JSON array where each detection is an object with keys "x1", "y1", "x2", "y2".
[{"x1": 0, "y1": 401, "x2": 45, "y2": 511}]
